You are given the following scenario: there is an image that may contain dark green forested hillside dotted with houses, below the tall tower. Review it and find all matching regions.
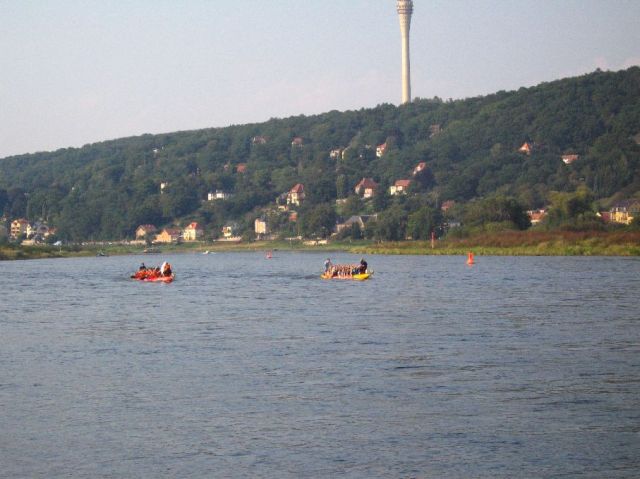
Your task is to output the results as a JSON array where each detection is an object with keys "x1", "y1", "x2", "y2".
[{"x1": 0, "y1": 67, "x2": 640, "y2": 240}]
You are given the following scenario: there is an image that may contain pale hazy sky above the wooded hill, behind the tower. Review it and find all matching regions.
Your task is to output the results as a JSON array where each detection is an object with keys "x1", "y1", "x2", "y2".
[{"x1": 0, "y1": 0, "x2": 640, "y2": 158}]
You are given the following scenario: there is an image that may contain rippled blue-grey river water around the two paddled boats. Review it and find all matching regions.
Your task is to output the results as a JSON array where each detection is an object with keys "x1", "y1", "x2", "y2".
[{"x1": 0, "y1": 252, "x2": 640, "y2": 478}]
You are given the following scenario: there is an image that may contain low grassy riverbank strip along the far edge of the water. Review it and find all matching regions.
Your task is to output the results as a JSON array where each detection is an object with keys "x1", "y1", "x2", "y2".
[{"x1": 0, "y1": 231, "x2": 640, "y2": 260}]
